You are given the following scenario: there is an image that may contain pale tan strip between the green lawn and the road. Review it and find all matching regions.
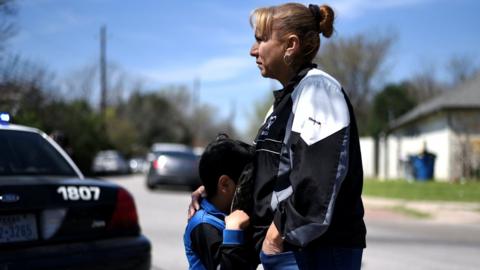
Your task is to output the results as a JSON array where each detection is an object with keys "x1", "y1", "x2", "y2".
[{"x1": 363, "y1": 196, "x2": 480, "y2": 225}]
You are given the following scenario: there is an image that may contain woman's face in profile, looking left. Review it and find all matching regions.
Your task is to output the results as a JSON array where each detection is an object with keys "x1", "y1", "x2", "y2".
[{"x1": 250, "y1": 31, "x2": 288, "y2": 81}]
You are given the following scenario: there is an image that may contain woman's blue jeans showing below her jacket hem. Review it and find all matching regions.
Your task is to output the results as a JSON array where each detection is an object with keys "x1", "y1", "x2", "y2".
[{"x1": 260, "y1": 248, "x2": 363, "y2": 270}]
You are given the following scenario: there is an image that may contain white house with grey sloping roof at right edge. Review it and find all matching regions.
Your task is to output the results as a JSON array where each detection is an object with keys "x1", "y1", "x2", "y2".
[{"x1": 378, "y1": 74, "x2": 480, "y2": 181}]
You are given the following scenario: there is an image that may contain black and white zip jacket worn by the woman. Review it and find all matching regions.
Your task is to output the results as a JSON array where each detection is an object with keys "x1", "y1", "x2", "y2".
[{"x1": 252, "y1": 65, "x2": 366, "y2": 250}]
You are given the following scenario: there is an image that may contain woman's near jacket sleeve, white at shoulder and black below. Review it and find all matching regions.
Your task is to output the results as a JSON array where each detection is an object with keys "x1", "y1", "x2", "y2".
[{"x1": 274, "y1": 75, "x2": 350, "y2": 246}]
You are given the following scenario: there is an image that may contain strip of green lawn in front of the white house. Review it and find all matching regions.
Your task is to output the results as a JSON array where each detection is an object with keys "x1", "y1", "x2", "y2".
[{"x1": 363, "y1": 179, "x2": 480, "y2": 202}]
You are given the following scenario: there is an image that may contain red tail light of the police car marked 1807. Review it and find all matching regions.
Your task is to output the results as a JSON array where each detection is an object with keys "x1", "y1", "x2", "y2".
[{"x1": 108, "y1": 188, "x2": 139, "y2": 230}]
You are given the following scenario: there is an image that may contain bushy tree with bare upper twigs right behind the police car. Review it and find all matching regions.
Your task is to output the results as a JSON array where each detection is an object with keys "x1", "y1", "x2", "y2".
[{"x1": 0, "y1": 55, "x2": 109, "y2": 173}]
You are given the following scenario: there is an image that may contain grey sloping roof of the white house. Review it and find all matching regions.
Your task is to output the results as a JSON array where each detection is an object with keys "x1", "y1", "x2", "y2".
[{"x1": 390, "y1": 75, "x2": 480, "y2": 130}]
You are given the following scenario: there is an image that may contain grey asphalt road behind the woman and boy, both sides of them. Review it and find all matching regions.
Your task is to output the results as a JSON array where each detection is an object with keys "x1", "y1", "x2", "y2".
[{"x1": 105, "y1": 175, "x2": 480, "y2": 270}]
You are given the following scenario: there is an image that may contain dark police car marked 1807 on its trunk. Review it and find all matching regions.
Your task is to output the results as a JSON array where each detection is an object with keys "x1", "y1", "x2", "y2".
[{"x1": 0, "y1": 113, "x2": 151, "y2": 269}]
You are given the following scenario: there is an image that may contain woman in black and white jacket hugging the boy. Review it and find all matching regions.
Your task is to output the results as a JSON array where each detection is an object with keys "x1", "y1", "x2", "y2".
[{"x1": 192, "y1": 3, "x2": 366, "y2": 269}]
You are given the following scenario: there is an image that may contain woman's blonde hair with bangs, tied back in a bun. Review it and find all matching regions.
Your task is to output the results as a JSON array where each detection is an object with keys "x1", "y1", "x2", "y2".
[{"x1": 250, "y1": 3, "x2": 335, "y2": 64}]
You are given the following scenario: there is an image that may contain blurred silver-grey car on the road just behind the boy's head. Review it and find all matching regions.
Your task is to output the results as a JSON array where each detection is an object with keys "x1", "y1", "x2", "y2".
[{"x1": 147, "y1": 143, "x2": 200, "y2": 189}]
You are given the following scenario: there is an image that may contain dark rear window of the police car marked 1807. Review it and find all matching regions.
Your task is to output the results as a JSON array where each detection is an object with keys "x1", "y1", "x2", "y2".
[{"x1": 0, "y1": 130, "x2": 78, "y2": 176}]
